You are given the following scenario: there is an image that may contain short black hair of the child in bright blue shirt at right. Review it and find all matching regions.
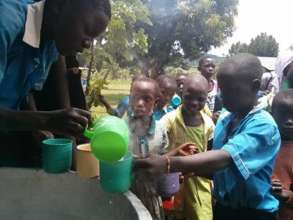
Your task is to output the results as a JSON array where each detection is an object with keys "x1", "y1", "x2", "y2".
[{"x1": 218, "y1": 53, "x2": 263, "y2": 81}]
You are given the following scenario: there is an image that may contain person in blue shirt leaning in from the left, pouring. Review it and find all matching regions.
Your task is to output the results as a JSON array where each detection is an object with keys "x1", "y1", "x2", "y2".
[{"x1": 0, "y1": 0, "x2": 111, "y2": 165}]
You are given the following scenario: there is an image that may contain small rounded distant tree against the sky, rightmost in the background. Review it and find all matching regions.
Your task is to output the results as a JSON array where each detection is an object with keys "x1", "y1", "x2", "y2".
[{"x1": 249, "y1": 33, "x2": 279, "y2": 57}]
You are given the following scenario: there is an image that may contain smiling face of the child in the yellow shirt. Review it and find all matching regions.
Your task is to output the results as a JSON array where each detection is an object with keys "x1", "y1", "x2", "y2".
[{"x1": 182, "y1": 83, "x2": 208, "y2": 115}]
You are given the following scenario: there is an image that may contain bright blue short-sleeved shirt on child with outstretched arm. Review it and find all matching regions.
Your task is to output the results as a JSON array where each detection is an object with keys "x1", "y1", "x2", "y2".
[{"x1": 213, "y1": 109, "x2": 281, "y2": 212}]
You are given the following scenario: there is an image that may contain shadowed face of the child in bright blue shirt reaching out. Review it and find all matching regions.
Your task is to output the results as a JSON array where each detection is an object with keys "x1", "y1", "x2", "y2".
[{"x1": 218, "y1": 74, "x2": 258, "y2": 113}]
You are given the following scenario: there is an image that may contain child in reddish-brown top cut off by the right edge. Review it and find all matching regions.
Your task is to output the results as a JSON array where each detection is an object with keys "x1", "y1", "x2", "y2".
[{"x1": 272, "y1": 89, "x2": 293, "y2": 220}]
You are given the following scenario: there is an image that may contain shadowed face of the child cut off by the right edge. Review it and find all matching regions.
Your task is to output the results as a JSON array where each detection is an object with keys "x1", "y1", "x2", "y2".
[{"x1": 273, "y1": 97, "x2": 293, "y2": 140}]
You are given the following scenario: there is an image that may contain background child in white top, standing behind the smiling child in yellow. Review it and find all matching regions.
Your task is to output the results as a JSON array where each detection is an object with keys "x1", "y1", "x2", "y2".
[{"x1": 198, "y1": 57, "x2": 218, "y2": 113}]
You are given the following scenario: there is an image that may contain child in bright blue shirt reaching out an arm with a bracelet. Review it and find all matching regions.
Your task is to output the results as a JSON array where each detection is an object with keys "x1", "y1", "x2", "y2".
[{"x1": 135, "y1": 54, "x2": 280, "y2": 220}]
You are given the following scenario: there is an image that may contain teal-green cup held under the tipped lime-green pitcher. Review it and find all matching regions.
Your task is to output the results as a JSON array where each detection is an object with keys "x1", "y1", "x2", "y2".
[{"x1": 100, "y1": 152, "x2": 132, "y2": 193}]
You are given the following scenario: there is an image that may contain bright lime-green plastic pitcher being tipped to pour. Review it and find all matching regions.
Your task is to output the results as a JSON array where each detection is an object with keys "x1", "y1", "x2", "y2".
[{"x1": 84, "y1": 116, "x2": 129, "y2": 162}]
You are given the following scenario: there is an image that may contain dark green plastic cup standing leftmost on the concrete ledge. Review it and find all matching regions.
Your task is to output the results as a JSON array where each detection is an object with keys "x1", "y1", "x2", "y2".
[{"x1": 42, "y1": 138, "x2": 73, "y2": 173}]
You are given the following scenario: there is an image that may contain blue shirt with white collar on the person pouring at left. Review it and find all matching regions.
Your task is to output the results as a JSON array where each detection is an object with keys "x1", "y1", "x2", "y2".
[{"x1": 0, "y1": 0, "x2": 58, "y2": 110}]
